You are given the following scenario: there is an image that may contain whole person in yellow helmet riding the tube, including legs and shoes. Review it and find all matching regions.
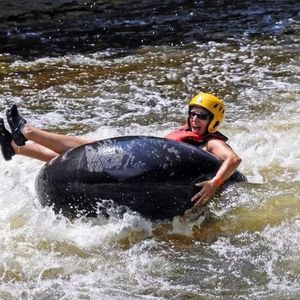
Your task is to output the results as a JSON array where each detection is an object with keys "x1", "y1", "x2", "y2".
[{"x1": 0, "y1": 93, "x2": 241, "y2": 205}]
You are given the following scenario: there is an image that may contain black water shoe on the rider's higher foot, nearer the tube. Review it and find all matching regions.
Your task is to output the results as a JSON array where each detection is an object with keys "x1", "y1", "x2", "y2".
[{"x1": 6, "y1": 104, "x2": 27, "y2": 146}]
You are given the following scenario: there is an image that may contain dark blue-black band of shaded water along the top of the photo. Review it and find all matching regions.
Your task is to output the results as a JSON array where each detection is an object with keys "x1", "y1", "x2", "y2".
[{"x1": 0, "y1": 0, "x2": 300, "y2": 56}]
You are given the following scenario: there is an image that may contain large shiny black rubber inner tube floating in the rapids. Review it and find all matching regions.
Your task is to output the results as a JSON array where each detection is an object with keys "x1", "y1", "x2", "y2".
[{"x1": 36, "y1": 136, "x2": 246, "y2": 219}]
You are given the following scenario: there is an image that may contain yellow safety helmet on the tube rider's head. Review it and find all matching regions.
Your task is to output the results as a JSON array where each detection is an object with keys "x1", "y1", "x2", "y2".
[{"x1": 189, "y1": 93, "x2": 225, "y2": 133}]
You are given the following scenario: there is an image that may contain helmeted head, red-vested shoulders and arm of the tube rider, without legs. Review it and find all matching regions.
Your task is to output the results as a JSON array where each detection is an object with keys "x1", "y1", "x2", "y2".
[{"x1": 166, "y1": 93, "x2": 241, "y2": 205}]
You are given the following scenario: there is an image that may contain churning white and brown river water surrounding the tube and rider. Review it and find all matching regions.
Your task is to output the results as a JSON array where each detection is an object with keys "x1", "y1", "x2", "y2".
[{"x1": 0, "y1": 0, "x2": 300, "y2": 300}]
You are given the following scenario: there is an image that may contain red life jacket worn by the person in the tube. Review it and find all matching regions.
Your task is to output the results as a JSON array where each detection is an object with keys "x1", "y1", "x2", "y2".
[{"x1": 165, "y1": 126, "x2": 228, "y2": 146}]
